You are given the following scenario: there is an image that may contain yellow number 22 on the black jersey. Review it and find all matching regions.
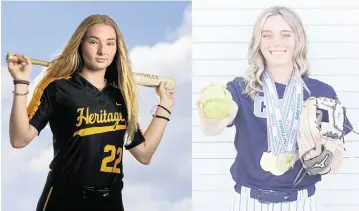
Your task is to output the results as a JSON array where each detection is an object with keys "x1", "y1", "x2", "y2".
[{"x1": 100, "y1": 145, "x2": 122, "y2": 173}]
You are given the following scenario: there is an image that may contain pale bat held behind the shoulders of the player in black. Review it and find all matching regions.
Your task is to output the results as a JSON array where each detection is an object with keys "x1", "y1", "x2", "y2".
[{"x1": 6, "y1": 53, "x2": 176, "y2": 90}]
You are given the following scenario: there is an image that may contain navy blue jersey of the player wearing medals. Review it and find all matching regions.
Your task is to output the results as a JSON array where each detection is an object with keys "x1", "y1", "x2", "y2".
[{"x1": 227, "y1": 76, "x2": 352, "y2": 192}]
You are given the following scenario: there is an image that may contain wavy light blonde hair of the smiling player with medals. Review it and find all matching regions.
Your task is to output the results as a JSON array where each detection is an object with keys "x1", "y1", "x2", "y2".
[{"x1": 243, "y1": 6, "x2": 310, "y2": 99}]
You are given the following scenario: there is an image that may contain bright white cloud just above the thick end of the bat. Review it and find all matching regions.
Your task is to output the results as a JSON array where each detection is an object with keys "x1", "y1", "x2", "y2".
[{"x1": 130, "y1": 5, "x2": 191, "y2": 83}]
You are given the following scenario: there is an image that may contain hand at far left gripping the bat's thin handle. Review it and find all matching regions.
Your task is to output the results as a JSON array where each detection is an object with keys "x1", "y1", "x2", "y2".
[{"x1": 7, "y1": 54, "x2": 32, "y2": 81}]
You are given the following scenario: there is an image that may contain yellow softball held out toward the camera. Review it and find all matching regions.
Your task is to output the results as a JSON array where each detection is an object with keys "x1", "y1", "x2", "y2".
[{"x1": 199, "y1": 83, "x2": 232, "y2": 119}]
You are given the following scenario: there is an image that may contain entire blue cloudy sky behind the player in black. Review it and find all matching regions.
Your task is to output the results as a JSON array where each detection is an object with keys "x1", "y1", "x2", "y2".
[{"x1": 1, "y1": 2, "x2": 192, "y2": 211}]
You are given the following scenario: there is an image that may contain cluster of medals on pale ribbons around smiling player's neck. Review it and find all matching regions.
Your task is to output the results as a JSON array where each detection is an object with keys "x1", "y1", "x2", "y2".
[{"x1": 261, "y1": 70, "x2": 305, "y2": 176}]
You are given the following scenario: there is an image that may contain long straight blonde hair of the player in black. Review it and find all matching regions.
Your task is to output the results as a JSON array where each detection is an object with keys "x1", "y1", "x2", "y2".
[{"x1": 34, "y1": 15, "x2": 138, "y2": 140}]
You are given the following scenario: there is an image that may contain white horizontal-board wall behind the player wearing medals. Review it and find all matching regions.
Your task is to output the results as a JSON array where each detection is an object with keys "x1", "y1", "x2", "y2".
[{"x1": 192, "y1": 0, "x2": 359, "y2": 211}]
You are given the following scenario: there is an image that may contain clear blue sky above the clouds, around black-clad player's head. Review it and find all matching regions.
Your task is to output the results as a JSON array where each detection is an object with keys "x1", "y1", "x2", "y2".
[{"x1": 1, "y1": 1, "x2": 190, "y2": 80}]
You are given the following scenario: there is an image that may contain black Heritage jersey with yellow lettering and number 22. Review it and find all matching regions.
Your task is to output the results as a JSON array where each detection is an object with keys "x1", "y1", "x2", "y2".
[{"x1": 28, "y1": 73, "x2": 144, "y2": 187}]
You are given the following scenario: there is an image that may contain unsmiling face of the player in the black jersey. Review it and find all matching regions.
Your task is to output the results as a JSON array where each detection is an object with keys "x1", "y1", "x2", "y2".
[{"x1": 81, "y1": 24, "x2": 117, "y2": 71}]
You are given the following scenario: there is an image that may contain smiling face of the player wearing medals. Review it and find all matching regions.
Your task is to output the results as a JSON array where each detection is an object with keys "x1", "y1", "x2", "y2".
[{"x1": 260, "y1": 15, "x2": 295, "y2": 67}]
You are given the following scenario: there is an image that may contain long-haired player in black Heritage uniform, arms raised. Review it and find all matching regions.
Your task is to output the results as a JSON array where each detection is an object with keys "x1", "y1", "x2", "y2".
[{"x1": 8, "y1": 15, "x2": 174, "y2": 211}]
